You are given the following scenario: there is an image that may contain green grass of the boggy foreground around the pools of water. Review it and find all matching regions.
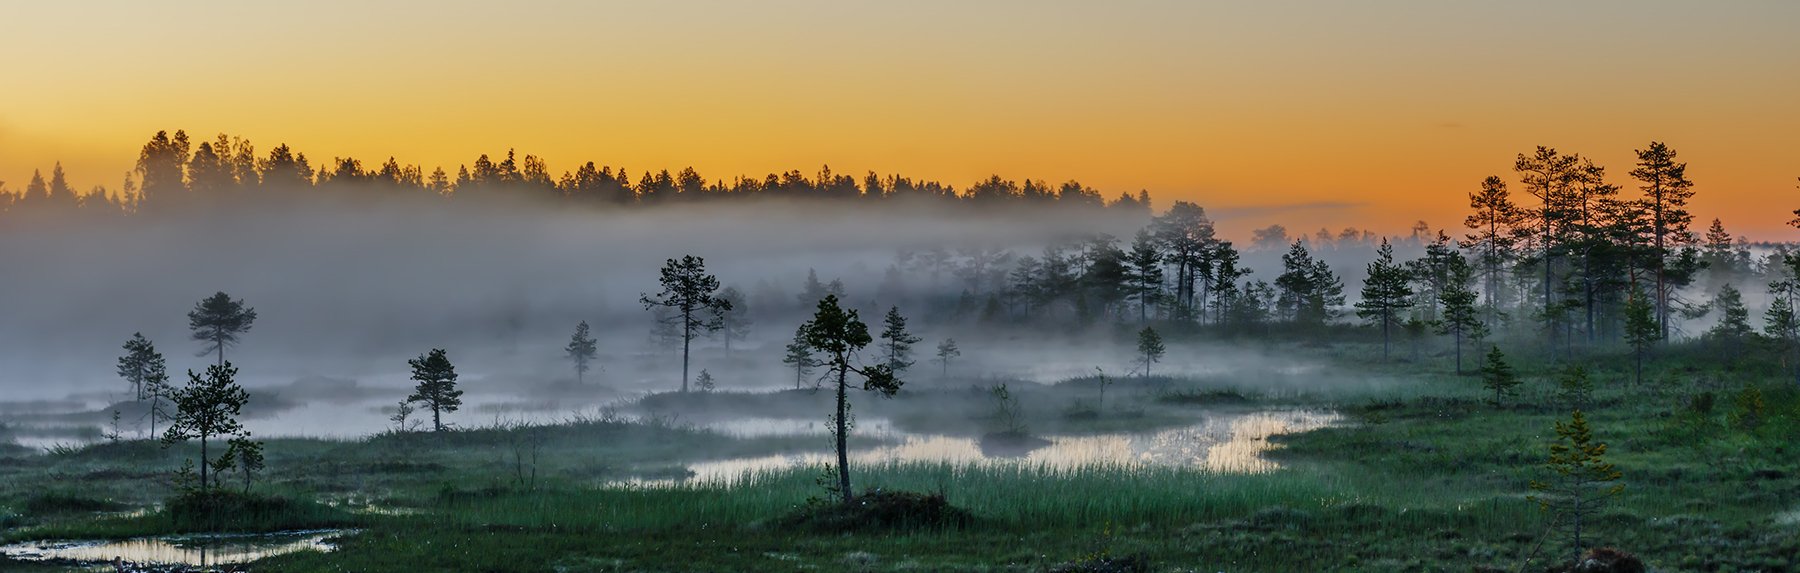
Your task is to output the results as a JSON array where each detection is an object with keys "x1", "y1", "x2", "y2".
[{"x1": 10, "y1": 338, "x2": 1800, "y2": 571}]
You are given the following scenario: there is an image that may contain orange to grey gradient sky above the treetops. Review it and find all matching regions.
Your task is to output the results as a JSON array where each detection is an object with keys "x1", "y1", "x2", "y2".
[{"x1": 0, "y1": 0, "x2": 1800, "y2": 240}]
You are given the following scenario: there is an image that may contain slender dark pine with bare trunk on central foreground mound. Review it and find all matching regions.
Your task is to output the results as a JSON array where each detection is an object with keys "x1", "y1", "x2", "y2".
[{"x1": 801, "y1": 296, "x2": 902, "y2": 505}]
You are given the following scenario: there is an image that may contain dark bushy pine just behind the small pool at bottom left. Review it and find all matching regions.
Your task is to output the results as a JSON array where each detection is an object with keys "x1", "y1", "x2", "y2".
[{"x1": 162, "y1": 362, "x2": 250, "y2": 490}]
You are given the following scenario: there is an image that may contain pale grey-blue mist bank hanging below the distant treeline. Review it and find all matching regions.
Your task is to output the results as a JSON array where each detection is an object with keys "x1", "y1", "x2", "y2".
[{"x1": 0, "y1": 194, "x2": 1147, "y2": 405}]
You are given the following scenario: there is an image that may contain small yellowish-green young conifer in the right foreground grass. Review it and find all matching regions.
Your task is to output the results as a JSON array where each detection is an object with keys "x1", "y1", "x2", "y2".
[{"x1": 1530, "y1": 409, "x2": 1625, "y2": 557}]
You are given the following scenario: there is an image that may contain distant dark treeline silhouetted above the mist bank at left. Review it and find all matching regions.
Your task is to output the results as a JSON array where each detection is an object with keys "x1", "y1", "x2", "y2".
[{"x1": 0, "y1": 132, "x2": 1150, "y2": 216}]
